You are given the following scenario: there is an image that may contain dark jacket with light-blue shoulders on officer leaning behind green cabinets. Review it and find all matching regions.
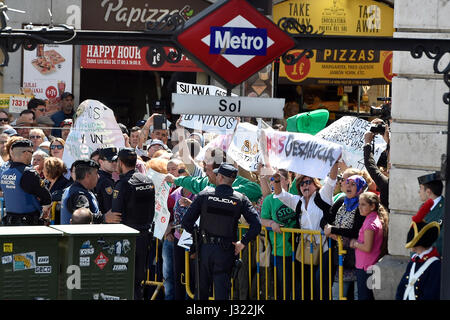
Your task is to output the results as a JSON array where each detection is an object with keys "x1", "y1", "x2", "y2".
[{"x1": 61, "y1": 181, "x2": 104, "y2": 224}]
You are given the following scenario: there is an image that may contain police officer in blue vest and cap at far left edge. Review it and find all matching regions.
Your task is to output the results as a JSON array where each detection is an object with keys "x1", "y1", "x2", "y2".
[{"x1": 0, "y1": 139, "x2": 52, "y2": 226}]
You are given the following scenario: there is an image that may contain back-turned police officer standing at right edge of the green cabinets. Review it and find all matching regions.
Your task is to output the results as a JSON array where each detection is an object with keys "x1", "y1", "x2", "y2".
[{"x1": 112, "y1": 148, "x2": 155, "y2": 300}]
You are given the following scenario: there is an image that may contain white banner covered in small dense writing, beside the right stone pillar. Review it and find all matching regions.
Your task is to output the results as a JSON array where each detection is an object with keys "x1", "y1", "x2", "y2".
[{"x1": 315, "y1": 116, "x2": 386, "y2": 170}]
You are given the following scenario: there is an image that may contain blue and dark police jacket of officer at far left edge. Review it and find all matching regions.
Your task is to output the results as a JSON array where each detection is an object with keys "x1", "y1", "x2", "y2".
[{"x1": 0, "y1": 162, "x2": 51, "y2": 214}]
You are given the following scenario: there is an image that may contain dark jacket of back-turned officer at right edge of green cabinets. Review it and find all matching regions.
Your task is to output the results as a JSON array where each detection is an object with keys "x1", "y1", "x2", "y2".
[{"x1": 111, "y1": 170, "x2": 155, "y2": 231}]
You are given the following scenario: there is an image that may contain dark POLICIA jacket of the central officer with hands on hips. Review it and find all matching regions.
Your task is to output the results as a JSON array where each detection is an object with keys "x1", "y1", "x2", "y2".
[{"x1": 181, "y1": 184, "x2": 261, "y2": 246}]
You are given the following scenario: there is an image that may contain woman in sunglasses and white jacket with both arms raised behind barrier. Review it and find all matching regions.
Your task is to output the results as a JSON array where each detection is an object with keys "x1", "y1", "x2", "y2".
[{"x1": 273, "y1": 162, "x2": 338, "y2": 300}]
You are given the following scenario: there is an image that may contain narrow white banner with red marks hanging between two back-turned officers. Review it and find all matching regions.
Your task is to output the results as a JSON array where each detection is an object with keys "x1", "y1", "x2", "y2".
[{"x1": 147, "y1": 168, "x2": 170, "y2": 240}]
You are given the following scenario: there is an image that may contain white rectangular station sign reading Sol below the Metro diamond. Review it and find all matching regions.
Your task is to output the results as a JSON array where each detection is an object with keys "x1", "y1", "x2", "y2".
[{"x1": 172, "y1": 93, "x2": 284, "y2": 119}]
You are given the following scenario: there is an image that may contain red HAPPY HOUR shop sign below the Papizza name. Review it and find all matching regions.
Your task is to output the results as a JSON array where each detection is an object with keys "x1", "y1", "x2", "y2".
[{"x1": 80, "y1": 45, "x2": 202, "y2": 72}]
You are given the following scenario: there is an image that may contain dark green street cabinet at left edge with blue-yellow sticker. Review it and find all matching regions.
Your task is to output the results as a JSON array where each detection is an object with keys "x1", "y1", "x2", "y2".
[{"x1": 0, "y1": 226, "x2": 63, "y2": 300}]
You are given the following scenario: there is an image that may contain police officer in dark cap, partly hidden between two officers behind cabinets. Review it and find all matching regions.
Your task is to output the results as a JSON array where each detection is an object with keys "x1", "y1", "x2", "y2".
[{"x1": 94, "y1": 147, "x2": 118, "y2": 212}]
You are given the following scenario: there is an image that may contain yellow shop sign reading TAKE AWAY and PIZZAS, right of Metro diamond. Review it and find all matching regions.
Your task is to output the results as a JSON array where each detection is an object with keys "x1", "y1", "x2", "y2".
[{"x1": 273, "y1": 0, "x2": 394, "y2": 85}]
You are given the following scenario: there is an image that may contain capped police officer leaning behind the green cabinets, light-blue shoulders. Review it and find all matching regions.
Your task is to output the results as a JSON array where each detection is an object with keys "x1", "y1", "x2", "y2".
[{"x1": 61, "y1": 160, "x2": 120, "y2": 224}]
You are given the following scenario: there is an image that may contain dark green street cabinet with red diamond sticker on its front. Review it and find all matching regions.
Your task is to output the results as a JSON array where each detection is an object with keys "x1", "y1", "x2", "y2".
[{"x1": 51, "y1": 224, "x2": 139, "y2": 300}]
